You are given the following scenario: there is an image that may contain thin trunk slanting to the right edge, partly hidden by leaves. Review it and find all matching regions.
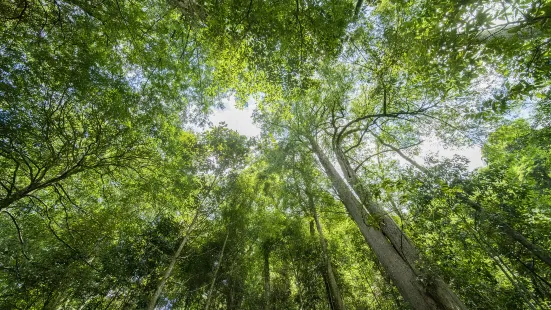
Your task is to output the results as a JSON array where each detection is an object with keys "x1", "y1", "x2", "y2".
[{"x1": 382, "y1": 135, "x2": 551, "y2": 267}]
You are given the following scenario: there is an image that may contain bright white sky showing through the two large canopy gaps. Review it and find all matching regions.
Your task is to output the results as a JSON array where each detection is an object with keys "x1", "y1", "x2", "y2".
[{"x1": 210, "y1": 100, "x2": 484, "y2": 171}]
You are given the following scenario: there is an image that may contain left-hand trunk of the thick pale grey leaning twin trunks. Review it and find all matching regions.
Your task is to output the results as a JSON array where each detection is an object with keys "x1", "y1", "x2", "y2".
[{"x1": 310, "y1": 137, "x2": 443, "y2": 310}]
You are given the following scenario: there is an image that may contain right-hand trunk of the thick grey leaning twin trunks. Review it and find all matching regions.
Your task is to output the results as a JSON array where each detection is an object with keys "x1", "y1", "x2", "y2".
[{"x1": 334, "y1": 146, "x2": 467, "y2": 309}]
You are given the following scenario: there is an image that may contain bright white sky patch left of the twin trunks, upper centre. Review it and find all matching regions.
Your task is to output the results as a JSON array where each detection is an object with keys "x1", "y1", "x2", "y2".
[{"x1": 209, "y1": 97, "x2": 260, "y2": 137}]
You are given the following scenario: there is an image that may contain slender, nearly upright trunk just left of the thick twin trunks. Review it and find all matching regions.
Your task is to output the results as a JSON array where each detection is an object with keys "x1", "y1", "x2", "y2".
[{"x1": 306, "y1": 191, "x2": 344, "y2": 310}]
